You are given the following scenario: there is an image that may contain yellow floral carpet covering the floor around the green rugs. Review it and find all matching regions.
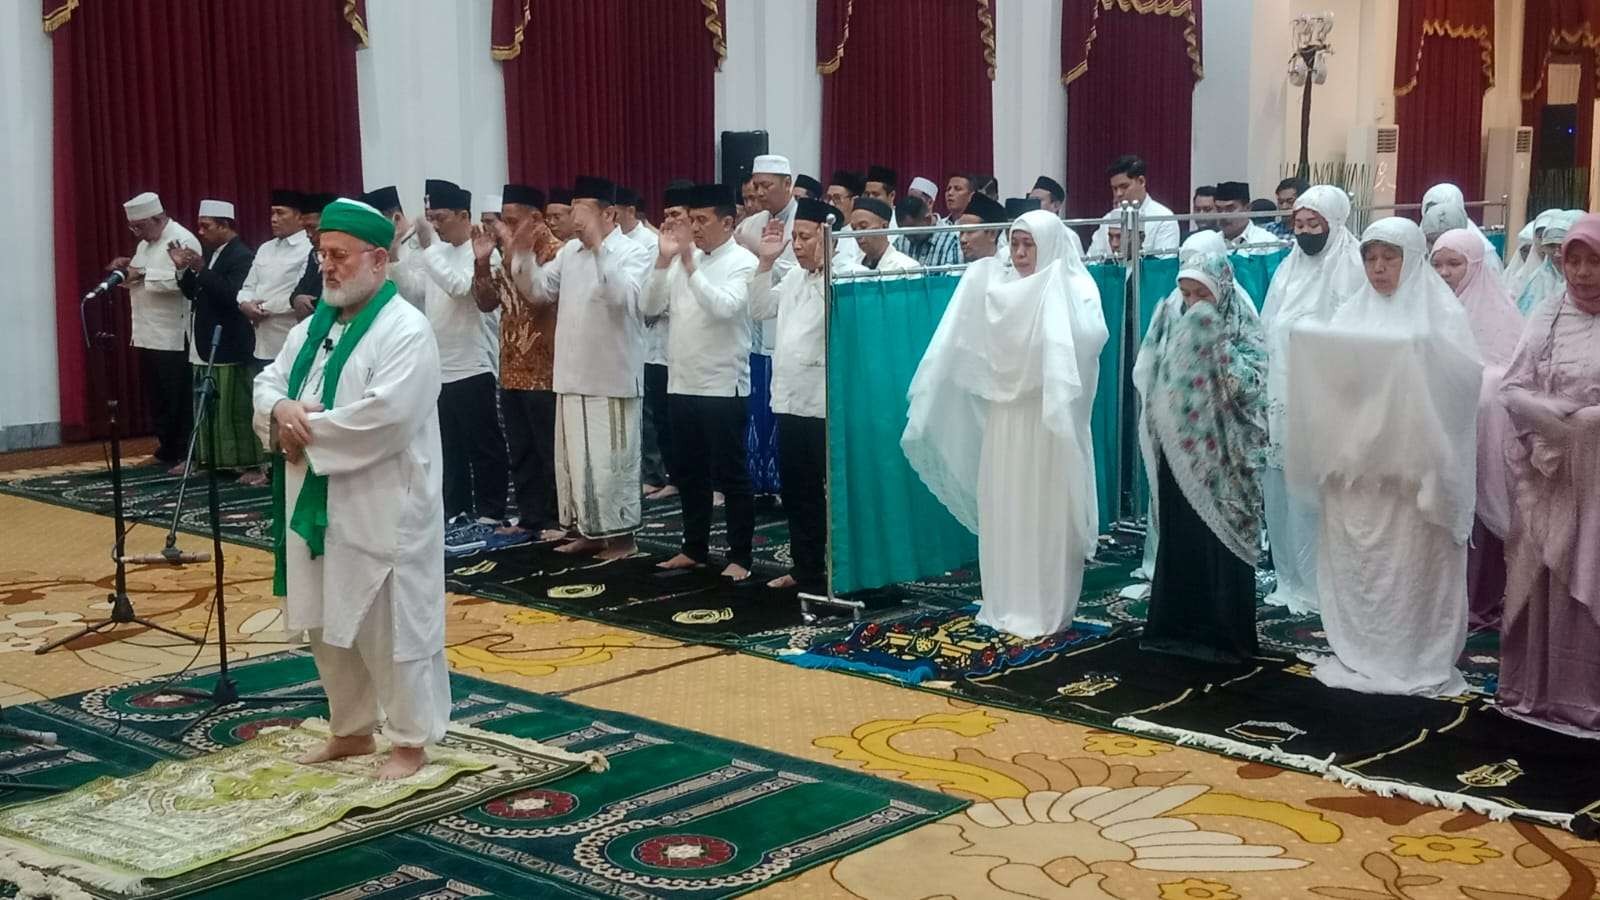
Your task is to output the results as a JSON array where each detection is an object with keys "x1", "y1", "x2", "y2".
[{"x1": 0, "y1": 496, "x2": 1600, "y2": 900}]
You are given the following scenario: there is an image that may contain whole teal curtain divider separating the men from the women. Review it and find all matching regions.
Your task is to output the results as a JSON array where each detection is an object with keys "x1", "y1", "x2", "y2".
[{"x1": 827, "y1": 251, "x2": 1286, "y2": 594}]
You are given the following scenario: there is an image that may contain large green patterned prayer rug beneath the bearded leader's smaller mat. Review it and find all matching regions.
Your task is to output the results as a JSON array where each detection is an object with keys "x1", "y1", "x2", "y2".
[{"x1": 0, "y1": 652, "x2": 966, "y2": 900}]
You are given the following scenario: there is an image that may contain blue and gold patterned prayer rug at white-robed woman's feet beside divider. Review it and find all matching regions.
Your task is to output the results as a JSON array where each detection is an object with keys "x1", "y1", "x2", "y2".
[{"x1": 779, "y1": 605, "x2": 1106, "y2": 684}]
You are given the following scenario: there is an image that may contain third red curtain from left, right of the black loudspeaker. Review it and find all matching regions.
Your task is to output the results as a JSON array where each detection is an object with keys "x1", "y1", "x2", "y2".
[{"x1": 819, "y1": 0, "x2": 992, "y2": 208}]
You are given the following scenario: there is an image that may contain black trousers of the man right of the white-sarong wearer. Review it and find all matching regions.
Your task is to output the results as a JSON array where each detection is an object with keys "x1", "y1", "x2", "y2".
[{"x1": 667, "y1": 394, "x2": 755, "y2": 569}]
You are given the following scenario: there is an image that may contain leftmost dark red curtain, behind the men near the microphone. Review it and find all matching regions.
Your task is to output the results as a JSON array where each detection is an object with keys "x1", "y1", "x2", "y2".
[{"x1": 43, "y1": 0, "x2": 366, "y2": 440}]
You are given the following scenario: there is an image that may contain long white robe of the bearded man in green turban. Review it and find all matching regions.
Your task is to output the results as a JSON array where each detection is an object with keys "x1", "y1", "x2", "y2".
[{"x1": 254, "y1": 296, "x2": 445, "y2": 663}]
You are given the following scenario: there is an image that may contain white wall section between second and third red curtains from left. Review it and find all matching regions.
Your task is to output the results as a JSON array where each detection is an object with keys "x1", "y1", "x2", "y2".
[{"x1": 712, "y1": 0, "x2": 829, "y2": 183}]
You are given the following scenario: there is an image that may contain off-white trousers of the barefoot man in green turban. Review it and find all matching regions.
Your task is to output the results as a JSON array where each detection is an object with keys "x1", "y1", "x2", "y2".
[{"x1": 310, "y1": 586, "x2": 450, "y2": 746}]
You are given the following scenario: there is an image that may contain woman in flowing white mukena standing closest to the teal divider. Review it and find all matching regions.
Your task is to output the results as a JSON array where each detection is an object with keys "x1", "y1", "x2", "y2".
[{"x1": 901, "y1": 210, "x2": 1107, "y2": 637}]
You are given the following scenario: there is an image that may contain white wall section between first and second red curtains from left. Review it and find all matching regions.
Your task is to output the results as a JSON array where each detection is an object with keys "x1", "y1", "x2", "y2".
[{"x1": 355, "y1": 0, "x2": 505, "y2": 215}]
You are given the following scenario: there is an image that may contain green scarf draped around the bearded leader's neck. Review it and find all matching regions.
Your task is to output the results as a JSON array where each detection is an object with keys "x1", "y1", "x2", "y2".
[{"x1": 272, "y1": 282, "x2": 395, "y2": 597}]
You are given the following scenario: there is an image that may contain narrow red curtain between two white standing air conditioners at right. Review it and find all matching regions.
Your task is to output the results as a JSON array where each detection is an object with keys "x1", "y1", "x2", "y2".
[{"x1": 1395, "y1": 0, "x2": 1494, "y2": 203}]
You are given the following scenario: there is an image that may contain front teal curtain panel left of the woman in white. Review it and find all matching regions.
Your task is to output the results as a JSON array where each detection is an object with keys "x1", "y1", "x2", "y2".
[{"x1": 827, "y1": 275, "x2": 978, "y2": 594}]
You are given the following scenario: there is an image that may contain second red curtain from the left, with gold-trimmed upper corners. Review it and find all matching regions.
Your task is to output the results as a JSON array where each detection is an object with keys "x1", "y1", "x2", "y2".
[{"x1": 491, "y1": 0, "x2": 726, "y2": 219}]
